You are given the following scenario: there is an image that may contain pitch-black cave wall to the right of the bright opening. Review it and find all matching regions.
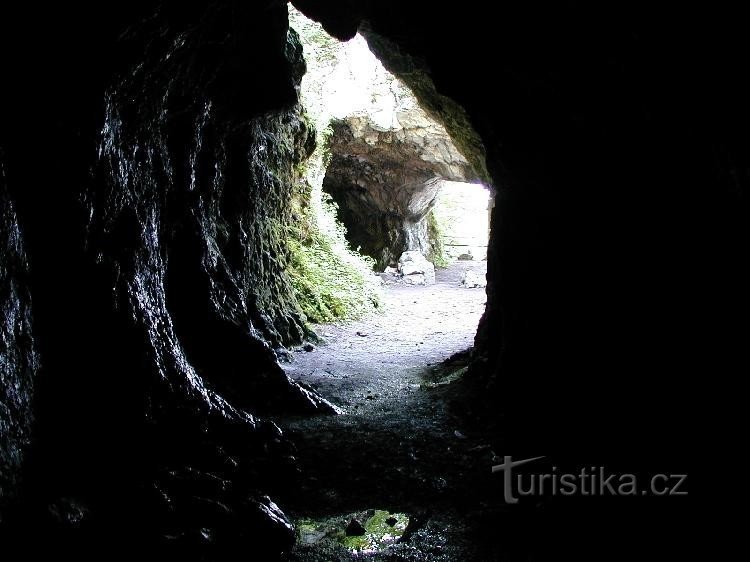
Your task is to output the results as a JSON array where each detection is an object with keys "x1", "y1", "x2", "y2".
[{"x1": 295, "y1": 0, "x2": 750, "y2": 560}]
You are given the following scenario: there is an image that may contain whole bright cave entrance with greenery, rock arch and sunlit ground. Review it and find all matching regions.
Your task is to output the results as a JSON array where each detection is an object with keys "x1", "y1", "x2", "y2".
[{"x1": 290, "y1": 7, "x2": 492, "y2": 384}]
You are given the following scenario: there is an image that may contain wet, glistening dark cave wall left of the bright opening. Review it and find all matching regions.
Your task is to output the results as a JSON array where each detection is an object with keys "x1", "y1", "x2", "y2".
[{"x1": 0, "y1": 2, "x2": 333, "y2": 558}]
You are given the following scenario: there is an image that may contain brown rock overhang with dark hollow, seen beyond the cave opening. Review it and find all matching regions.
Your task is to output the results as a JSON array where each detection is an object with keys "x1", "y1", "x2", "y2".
[{"x1": 323, "y1": 107, "x2": 470, "y2": 268}]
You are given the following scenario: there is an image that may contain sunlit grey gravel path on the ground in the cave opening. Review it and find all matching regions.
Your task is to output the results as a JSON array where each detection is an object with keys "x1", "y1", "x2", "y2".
[{"x1": 286, "y1": 261, "x2": 487, "y2": 415}]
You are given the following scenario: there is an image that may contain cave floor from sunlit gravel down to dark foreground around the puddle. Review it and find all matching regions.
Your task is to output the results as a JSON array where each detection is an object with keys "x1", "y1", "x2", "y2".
[{"x1": 276, "y1": 262, "x2": 508, "y2": 561}]
